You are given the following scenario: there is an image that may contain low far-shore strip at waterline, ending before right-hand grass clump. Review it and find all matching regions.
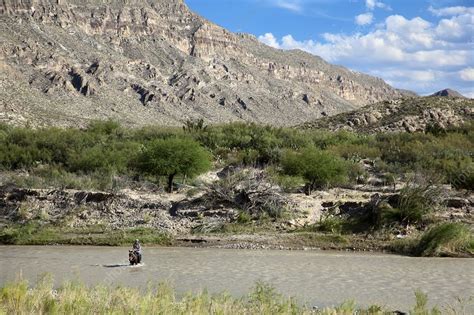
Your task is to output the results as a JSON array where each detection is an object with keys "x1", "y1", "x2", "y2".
[{"x1": 0, "y1": 224, "x2": 390, "y2": 252}]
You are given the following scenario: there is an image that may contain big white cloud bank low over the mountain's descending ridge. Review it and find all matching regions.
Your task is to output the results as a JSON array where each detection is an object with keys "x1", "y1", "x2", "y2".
[{"x1": 259, "y1": 11, "x2": 474, "y2": 94}]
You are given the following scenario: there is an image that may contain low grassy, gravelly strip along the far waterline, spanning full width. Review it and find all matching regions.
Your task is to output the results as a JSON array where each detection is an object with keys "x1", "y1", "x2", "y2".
[{"x1": 0, "y1": 224, "x2": 474, "y2": 258}]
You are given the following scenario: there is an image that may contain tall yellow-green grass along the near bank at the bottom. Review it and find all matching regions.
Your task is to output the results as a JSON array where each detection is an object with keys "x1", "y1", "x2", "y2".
[{"x1": 0, "y1": 276, "x2": 465, "y2": 315}]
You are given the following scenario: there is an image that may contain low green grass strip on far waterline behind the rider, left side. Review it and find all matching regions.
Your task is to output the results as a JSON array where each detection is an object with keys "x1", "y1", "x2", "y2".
[{"x1": 0, "y1": 222, "x2": 172, "y2": 246}]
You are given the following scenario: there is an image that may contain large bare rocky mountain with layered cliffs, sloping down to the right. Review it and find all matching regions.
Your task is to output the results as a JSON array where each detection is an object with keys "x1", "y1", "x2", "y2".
[{"x1": 0, "y1": 0, "x2": 401, "y2": 126}]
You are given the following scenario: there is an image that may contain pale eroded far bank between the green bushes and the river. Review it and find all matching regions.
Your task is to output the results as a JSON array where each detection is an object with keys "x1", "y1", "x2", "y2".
[{"x1": 0, "y1": 177, "x2": 474, "y2": 257}]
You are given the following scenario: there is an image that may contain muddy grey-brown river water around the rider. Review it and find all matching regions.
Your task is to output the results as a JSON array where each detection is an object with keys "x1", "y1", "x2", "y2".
[{"x1": 0, "y1": 246, "x2": 474, "y2": 313}]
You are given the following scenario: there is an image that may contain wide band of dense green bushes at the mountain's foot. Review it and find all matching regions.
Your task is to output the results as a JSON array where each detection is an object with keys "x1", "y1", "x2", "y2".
[{"x1": 0, "y1": 121, "x2": 474, "y2": 189}]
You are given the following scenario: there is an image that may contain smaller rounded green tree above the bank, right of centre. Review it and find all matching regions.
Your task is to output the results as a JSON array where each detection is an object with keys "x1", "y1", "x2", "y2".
[{"x1": 282, "y1": 147, "x2": 348, "y2": 195}]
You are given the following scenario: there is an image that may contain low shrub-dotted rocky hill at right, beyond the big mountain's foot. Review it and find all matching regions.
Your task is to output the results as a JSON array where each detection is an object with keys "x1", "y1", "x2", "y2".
[{"x1": 302, "y1": 96, "x2": 474, "y2": 133}]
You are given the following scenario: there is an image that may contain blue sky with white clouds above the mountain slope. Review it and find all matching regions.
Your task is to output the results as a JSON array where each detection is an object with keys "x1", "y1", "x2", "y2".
[{"x1": 185, "y1": 0, "x2": 474, "y2": 98}]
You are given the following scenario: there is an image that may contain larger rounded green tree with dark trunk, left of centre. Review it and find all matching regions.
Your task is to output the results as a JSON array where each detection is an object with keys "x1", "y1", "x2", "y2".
[{"x1": 136, "y1": 138, "x2": 211, "y2": 193}]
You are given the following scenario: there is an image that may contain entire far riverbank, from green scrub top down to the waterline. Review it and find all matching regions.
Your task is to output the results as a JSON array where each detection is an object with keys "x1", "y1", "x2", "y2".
[{"x1": 0, "y1": 122, "x2": 474, "y2": 257}]
